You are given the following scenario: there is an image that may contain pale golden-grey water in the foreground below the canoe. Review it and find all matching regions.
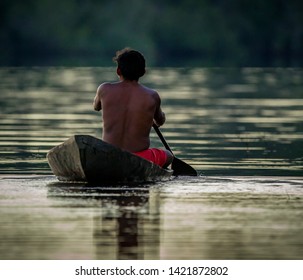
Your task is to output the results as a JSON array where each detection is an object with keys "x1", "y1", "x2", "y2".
[{"x1": 0, "y1": 175, "x2": 303, "y2": 260}]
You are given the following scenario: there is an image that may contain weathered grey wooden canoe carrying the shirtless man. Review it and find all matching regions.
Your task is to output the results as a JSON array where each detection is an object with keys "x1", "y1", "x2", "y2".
[{"x1": 47, "y1": 135, "x2": 172, "y2": 183}]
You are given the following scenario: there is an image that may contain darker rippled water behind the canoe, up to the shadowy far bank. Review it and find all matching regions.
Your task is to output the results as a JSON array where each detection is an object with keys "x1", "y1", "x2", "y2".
[{"x1": 0, "y1": 67, "x2": 303, "y2": 176}]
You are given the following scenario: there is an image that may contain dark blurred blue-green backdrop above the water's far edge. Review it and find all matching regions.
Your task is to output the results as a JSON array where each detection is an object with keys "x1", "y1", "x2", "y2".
[{"x1": 0, "y1": 0, "x2": 303, "y2": 67}]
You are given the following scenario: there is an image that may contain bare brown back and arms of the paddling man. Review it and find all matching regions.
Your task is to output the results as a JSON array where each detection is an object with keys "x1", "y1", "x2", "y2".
[{"x1": 94, "y1": 79, "x2": 165, "y2": 152}]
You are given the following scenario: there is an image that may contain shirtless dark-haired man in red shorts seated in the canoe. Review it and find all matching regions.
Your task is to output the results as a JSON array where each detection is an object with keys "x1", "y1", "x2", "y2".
[{"x1": 93, "y1": 49, "x2": 173, "y2": 168}]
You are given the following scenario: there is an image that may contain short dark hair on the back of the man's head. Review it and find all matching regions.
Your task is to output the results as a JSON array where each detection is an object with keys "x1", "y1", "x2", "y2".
[{"x1": 114, "y1": 48, "x2": 145, "y2": 81}]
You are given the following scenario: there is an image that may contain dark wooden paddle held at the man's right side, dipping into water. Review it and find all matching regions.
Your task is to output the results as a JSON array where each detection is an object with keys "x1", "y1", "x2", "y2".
[{"x1": 153, "y1": 124, "x2": 198, "y2": 176}]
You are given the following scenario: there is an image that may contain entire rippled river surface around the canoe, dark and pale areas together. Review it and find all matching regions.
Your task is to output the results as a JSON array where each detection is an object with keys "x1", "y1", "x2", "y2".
[{"x1": 0, "y1": 67, "x2": 303, "y2": 259}]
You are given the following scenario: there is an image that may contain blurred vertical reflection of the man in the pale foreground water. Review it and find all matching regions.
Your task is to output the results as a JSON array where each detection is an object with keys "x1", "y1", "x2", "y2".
[{"x1": 94, "y1": 187, "x2": 160, "y2": 260}]
